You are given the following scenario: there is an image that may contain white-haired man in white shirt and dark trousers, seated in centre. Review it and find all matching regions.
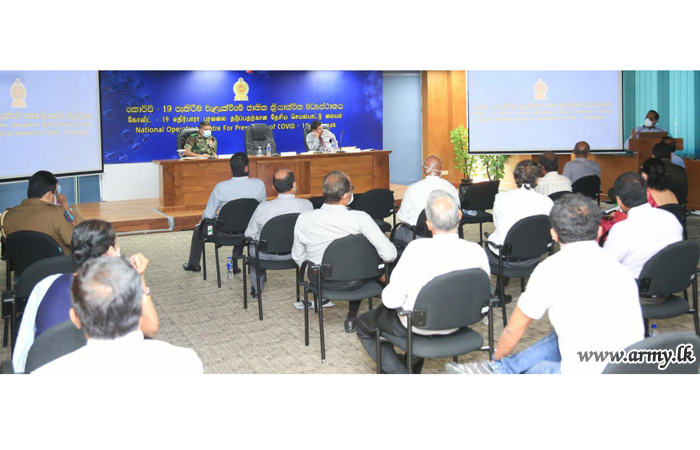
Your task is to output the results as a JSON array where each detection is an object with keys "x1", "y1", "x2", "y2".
[{"x1": 357, "y1": 190, "x2": 490, "y2": 373}]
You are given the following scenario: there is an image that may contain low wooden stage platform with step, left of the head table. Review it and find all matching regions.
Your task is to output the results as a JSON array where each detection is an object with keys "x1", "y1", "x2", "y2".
[{"x1": 73, "y1": 184, "x2": 408, "y2": 234}]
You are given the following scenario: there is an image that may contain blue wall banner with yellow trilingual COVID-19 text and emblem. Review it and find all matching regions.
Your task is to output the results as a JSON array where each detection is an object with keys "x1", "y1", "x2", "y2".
[{"x1": 100, "y1": 71, "x2": 383, "y2": 164}]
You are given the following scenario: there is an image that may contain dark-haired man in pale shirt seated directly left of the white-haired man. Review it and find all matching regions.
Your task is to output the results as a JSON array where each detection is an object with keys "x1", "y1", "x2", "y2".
[{"x1": 292, "y1": 171, "x2": 396, "y2": 333}]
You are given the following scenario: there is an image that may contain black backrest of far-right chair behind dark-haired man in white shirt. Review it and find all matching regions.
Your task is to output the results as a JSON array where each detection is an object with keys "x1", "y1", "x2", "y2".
[{"x1": 637, "y1": 240, "x2": 700, "y2": 295}]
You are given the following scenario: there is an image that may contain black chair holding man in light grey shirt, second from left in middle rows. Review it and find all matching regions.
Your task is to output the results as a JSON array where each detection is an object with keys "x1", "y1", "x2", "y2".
[{"x1": 243, "y1": 213, "x2": 300, "y2": 320}]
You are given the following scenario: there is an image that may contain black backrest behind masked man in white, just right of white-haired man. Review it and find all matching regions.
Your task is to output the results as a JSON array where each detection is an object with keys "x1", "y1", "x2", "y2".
[{"x1": 501, "y1": 214, "x2": 552, "y2": 259}]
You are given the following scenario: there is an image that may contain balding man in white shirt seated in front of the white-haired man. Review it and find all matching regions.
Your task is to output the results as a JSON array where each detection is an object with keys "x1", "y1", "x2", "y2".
[{"x1": 394, "y1": 156, "x2": 460, "y2": 244}]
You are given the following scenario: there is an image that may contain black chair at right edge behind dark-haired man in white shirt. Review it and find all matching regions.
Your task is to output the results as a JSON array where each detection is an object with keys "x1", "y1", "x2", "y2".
[{"x1": 637, "y1": 240, "x2": 700, "y2": 336}]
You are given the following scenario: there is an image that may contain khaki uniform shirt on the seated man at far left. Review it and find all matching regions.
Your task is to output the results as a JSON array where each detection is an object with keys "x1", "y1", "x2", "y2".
[{"x1": 2, "y1": 198, "x2": 74, "y2": 255}]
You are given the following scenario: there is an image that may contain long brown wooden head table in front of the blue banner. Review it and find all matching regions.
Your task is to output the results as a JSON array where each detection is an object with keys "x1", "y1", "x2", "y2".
[{"x1": 153, "y1": 150, "x2": 391, "y2": 213}]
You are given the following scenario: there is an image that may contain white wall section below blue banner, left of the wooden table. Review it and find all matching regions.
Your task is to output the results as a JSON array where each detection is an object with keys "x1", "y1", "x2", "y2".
[{"x1": 102, "y1": 163, "x2": 159, "y2": 202}]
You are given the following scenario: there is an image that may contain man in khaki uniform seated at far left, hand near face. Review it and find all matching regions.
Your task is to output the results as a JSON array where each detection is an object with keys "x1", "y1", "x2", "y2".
[{"x1": 0, "y1": 170, "x2": 75, "y2": 255}]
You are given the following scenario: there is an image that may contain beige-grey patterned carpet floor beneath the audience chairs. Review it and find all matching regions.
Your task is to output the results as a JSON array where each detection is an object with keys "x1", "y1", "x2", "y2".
[{"x1": 0, "y1": 216, "x2": 700, "y2": 374}]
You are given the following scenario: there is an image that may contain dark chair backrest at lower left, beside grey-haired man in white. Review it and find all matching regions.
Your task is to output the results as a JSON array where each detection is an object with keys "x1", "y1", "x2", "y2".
[{"x1": 24, "y1": 320, "x2": 87, "y2": 373}]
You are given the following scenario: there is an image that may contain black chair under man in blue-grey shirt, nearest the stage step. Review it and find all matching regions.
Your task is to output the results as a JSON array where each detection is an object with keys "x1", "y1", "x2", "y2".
[{"x1": 199, "y1": 198, "x2": 258, "y2": 287}]
